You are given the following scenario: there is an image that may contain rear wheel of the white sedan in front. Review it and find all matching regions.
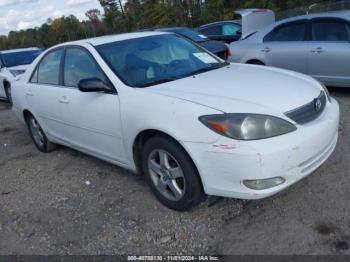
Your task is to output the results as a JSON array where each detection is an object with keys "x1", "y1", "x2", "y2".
[{"x1": 26, "y1": 114, "x2": 57, "y2": 153}]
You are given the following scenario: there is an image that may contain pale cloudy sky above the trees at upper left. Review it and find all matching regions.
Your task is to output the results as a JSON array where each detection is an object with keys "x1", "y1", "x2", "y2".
[{"x1": 0, "y1": 0, "x2": 102, "y2": 35}]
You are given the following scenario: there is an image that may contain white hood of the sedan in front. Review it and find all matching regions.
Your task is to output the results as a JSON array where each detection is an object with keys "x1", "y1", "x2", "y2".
[{"x1": 147, "y1": 64, "x2": 322, "y2": 115}]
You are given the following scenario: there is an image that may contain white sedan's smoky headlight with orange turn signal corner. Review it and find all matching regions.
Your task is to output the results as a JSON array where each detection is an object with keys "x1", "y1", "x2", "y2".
[{"x1": 199, "y1": 113, "x2": 297, "y2": 140}]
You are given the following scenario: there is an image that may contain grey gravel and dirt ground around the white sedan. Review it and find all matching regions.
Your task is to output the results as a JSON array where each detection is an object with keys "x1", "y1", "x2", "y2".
[{"x1": 0, "y1": 89, "x2": 350, "y2": 254}]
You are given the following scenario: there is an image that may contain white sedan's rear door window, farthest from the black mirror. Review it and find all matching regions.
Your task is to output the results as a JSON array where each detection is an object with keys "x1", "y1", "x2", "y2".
[{"x1": 36, "y1": 49, "x2": 63, "y2": 85}]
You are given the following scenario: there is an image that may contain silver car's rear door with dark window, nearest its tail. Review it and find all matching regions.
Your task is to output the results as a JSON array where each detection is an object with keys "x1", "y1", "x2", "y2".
[{"x1": 259, "y1": 20, "x2": 310, "y2": 73}]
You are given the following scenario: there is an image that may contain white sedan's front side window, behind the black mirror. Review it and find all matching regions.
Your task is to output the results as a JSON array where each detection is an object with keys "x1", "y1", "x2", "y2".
[{"x1": 64, "y1": 48, "x2": 107, "y2": 87}]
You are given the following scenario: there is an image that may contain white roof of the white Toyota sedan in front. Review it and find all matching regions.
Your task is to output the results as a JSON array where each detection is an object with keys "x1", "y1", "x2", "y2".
[{"x1": 61, "y1": 31, "x2": 171, "y2": 46}]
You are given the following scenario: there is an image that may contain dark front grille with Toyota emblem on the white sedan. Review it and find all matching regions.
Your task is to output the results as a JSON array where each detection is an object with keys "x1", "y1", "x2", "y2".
[{"x1": 285, "y1": 91, "x2": 327, "y2": 124}]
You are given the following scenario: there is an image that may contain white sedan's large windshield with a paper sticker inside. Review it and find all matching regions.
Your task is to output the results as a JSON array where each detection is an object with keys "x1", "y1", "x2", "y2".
[{"x1": 96, "y1": 34, "x2": 227, "y2": 87}]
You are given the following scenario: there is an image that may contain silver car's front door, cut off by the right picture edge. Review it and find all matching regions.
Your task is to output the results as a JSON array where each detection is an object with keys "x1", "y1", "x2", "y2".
[{"x1": 308, "y1": 18, "x2": 350, "y2": 85}]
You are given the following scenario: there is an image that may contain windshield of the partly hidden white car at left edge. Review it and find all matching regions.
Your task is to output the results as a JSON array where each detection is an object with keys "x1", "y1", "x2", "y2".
[{"x1": 1, "y1": 49, "x2": 43, "y2": 67}]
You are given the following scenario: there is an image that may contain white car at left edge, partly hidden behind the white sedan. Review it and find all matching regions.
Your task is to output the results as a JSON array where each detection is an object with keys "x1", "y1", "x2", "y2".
[{"x1": 0, "y1": 48, "x2": 42, "y2": 103}]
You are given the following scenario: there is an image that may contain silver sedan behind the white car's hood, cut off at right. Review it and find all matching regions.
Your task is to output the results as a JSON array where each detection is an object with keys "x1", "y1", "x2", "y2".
[{"x1": 229, "y1": 11, "x2": 350, "y2": 87}]
